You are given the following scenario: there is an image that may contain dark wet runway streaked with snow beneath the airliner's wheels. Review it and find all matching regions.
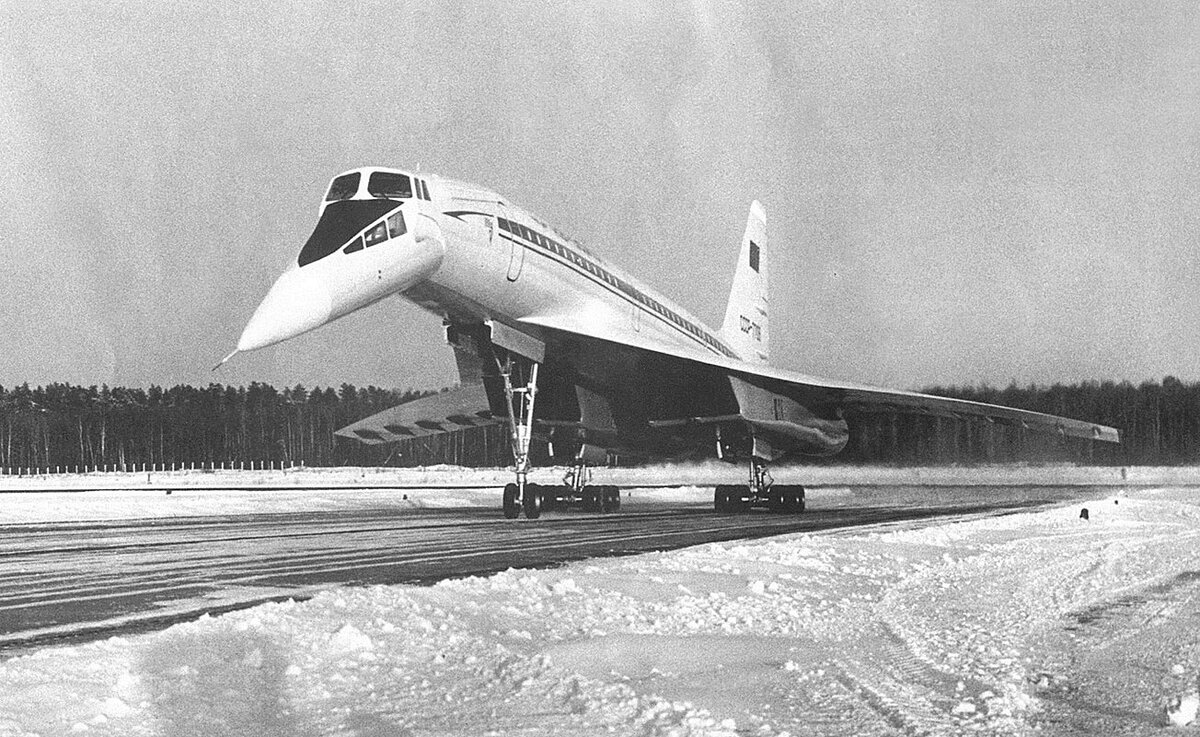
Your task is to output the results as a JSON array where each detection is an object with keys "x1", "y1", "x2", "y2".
[{"x1": 0, "y1": 487, "x2": 1094, "y2": 657}]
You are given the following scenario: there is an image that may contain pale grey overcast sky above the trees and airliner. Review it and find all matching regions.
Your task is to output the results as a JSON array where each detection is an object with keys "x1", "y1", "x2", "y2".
[{"x1": 0, "y1": 0, "x2": 1200, "y2": 388}]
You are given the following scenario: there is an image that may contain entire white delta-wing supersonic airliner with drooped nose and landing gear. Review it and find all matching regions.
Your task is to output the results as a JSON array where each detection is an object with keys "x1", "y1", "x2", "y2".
[{"x1": 222, "y1": 167, "x2": 1120, "y2": 519}]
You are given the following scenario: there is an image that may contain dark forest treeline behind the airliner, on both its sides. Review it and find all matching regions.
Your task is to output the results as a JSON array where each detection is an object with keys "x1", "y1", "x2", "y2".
[{"x1": 0, "y1": 377, "x2": 1200, "y2": 469}]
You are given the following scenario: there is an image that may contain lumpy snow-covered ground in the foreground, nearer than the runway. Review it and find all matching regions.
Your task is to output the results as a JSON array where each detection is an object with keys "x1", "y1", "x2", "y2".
[{"x1": 0, "y1": 487, "x2": 1200, "y2": 737}]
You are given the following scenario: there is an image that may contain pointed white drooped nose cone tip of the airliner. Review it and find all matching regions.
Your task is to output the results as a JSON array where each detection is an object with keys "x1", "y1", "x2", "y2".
[{"x1": 238, "y1": 268, "x2": 334, "y2": 350}]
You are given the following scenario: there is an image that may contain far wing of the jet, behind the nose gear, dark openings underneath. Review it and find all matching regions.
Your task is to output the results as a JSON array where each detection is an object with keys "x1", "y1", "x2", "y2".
[{"x1": 335, "y1": 384, "x2": 503, "y2": 445}]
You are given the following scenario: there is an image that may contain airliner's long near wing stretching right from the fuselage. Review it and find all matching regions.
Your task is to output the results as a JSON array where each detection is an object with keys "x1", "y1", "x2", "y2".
[{"x1": 521, "y1": 316, "x2": 1121, "y2": 443}]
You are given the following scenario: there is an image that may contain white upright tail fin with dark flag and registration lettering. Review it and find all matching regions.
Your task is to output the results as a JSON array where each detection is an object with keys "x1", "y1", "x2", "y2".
[{"x1": 721, "y1": 199, "x2": 770, "y2": 364}]
